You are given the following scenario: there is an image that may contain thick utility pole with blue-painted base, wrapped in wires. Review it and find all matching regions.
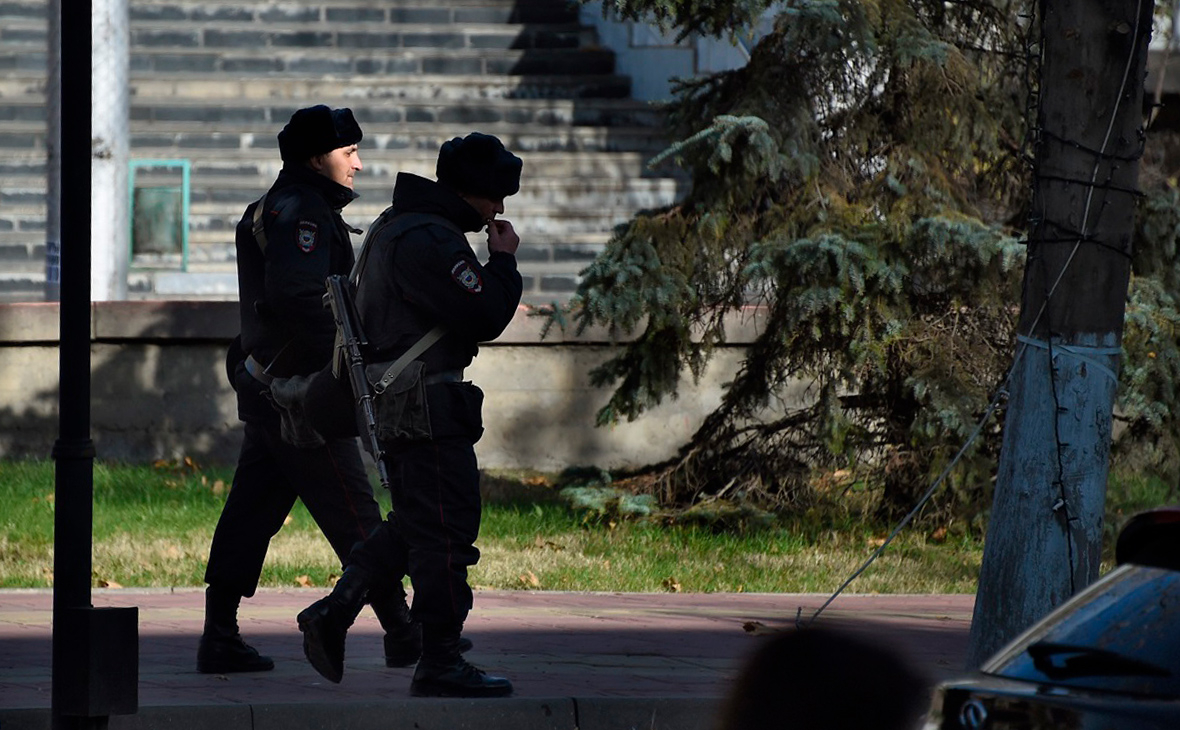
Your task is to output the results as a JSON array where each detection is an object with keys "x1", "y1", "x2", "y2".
[{"x1": 968, "y1": 0, "x2": 1154, "y2": 667}]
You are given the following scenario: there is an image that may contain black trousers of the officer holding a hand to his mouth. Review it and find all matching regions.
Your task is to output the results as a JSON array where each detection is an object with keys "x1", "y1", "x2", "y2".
[{"x1": 350, "y1": 436, "x2": 483, "y2": 624}]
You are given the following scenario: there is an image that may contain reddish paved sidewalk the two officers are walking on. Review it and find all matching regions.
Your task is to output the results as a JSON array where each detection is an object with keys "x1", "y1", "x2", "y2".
[{"x1": 0, "y1": 588, "x2": 974, "y2": 730}]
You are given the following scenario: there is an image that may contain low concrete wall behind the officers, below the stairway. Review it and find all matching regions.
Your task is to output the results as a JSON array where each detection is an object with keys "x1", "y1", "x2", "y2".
[{"x1": 0, "y1": 302, "x2": 758, "y2": 471}]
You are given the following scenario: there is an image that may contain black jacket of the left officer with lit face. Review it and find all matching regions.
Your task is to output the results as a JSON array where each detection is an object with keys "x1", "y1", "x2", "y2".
[{"x1": 235, "y1": 166, "x2": 356, "y2": 417}]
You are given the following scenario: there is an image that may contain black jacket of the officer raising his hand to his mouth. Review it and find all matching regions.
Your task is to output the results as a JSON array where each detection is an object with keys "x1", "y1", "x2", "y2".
[{"x1": 356, "y1": 172, "x2": 522, "y2": 373}]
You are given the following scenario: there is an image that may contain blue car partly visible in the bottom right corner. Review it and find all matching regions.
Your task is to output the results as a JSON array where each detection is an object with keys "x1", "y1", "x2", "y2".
[{"x1": 925, "y1": 508, "x2": 1180, "y2": 730}]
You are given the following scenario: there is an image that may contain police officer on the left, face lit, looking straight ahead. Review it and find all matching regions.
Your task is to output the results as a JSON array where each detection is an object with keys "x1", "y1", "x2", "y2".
[{"x1": 197, "y1": 105, "x2": 421, "y2": 673}]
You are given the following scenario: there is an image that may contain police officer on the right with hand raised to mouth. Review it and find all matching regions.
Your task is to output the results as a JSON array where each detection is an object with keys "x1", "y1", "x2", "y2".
[{"x1": 299, "y1": 132, "x2": 522, "y2": 697}]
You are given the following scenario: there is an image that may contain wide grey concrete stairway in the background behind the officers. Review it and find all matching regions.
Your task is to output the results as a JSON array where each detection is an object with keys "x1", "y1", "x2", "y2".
[{"x1": 0, "y1": 0, "x2": 686, "y2": 302}]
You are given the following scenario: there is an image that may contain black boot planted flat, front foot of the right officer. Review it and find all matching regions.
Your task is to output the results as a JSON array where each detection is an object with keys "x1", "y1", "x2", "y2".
[{"x1": 409, "y1": 624, "x2": 512, "y2": 697}]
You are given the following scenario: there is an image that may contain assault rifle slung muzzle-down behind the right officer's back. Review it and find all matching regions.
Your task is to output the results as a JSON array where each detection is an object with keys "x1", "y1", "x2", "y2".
[{"x1": 323, "y1": 274, "x2": 389, "y2": 489}]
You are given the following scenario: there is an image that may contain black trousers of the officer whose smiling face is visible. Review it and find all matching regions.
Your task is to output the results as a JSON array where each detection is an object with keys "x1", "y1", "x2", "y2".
[{"x1": 205, "y1": 419, "x2": 382, "y2": 597}]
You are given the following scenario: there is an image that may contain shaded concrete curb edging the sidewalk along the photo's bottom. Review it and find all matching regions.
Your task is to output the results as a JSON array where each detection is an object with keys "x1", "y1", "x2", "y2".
[{"x1": 0, "y1": 697, "x2": 719, "y2": 730}]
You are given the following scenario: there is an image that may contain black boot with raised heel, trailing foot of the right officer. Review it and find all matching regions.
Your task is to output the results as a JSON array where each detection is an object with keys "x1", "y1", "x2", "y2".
[{"x1": 297, "y1": 566, "x2": 369, "y2": 684}]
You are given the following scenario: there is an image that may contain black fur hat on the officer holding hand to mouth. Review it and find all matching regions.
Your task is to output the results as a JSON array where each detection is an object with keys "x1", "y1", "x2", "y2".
[{"x1": 434, "y1": 132, "x2": 524, "y2": 199}]
